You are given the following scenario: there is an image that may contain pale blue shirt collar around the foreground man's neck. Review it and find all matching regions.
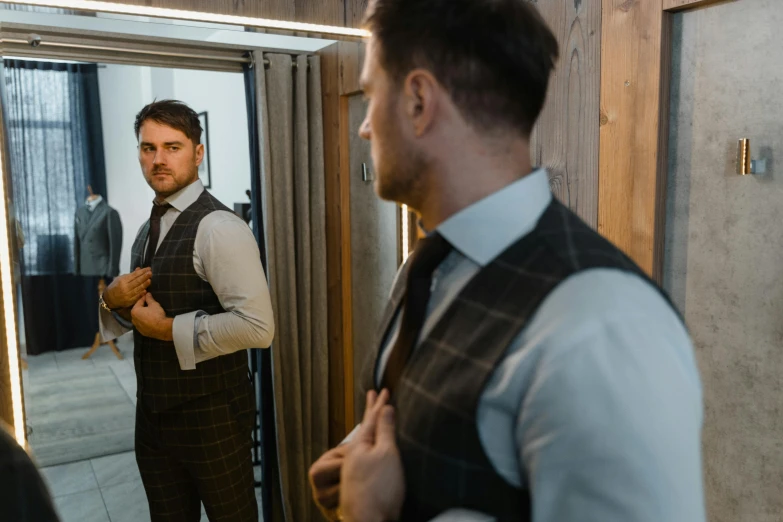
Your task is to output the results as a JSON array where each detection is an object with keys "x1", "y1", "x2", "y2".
[{"x1": 437, "y1": 168, "x2": 552, "y2": 266}]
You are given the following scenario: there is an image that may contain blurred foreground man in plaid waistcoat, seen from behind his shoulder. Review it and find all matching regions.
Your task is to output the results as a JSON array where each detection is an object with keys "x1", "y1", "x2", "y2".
[{"x1": 310, "y1": 0, "x2": 705, "y2": 522}]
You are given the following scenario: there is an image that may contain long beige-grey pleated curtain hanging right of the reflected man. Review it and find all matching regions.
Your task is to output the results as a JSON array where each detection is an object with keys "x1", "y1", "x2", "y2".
[{"x1": 255, "y1": 52, "x2": 329, "y2": 522}]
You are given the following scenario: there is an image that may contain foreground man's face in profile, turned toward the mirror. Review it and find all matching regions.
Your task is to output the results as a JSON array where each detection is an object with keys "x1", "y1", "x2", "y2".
[{"x1": 359, "y1": 38, "x2": 424, "y2": 208}]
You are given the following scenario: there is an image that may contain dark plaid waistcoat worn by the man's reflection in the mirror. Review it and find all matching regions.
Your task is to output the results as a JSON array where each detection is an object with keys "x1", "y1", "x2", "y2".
[{"x1": 131, "y1": 190, "x2": 248, "y2": 411}]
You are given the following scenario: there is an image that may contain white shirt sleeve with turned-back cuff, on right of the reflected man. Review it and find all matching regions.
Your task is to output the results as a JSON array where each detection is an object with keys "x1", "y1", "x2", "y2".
[{"x1": 172, "y1": 211, "x2": 275, "y2": 370}]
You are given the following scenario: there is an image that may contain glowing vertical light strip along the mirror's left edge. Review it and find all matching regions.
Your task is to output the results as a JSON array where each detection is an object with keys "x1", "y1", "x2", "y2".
[{"x1": 0, "y1": 146, "x2": 25, "y2": 446}]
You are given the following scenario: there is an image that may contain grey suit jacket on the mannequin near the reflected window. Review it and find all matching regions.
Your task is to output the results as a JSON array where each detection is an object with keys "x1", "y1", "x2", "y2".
[{"x1": 73, "y1": 201, "x2": 122, "y2": 277}]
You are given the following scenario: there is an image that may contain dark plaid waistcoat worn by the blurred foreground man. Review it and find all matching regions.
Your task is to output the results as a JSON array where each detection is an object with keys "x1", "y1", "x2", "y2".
[{"x1": 364, "y1": 197, "x2": 671, "y2": 522}]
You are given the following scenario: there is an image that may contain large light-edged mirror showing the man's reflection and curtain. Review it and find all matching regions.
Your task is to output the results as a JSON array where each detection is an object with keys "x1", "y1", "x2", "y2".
[{"x1": 0, "y1": 4, "x2": 410, "y2": 522}]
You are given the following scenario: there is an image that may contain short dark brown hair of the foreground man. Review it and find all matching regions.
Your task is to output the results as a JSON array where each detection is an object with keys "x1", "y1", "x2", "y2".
[{"x1": 364, "y1": 0, "x2": 558, "y2": 136}]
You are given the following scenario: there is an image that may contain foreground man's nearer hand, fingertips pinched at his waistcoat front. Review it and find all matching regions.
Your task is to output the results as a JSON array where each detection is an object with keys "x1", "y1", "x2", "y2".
[{"x1": 340, "y1": 390, "x2": 405, "y2": 522}]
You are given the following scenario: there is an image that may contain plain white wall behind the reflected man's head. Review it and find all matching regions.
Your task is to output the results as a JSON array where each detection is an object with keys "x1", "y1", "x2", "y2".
[{"x1": 98, "y1": 65, "x2": 250, "y2": 273}]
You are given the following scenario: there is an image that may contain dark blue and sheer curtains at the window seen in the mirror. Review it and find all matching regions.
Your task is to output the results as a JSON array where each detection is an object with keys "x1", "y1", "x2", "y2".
[{"x1": 4, "y1": 60, "x2": 106, "y2": 355}]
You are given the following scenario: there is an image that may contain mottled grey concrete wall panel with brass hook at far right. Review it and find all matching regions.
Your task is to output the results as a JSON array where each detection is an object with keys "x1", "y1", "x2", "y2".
[{"x1": 665, "y1": 0, "x2": 783, "y2": 522}]
